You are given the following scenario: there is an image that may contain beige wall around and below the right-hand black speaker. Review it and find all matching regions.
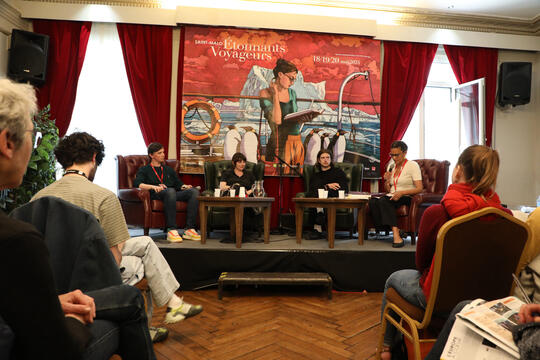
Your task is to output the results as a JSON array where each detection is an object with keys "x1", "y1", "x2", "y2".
[{"x1": 495, "y1": 50, "x2": 540, "y2": 208}]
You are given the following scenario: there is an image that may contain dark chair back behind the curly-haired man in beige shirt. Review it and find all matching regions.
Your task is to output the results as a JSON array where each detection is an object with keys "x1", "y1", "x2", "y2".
[{"x1": 10, "y1": 196, "x2": 122, "y2": 294}]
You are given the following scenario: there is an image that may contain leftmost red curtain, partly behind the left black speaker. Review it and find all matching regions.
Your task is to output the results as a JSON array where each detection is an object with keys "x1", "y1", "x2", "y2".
[{"x1": 33, "y1": 20, "x2": 92, "y2": 136}]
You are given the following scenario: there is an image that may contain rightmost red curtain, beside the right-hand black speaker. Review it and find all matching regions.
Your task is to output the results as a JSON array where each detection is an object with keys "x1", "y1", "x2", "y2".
[{"x1": 444, "y1": 45, "x2": 498, "y2": 146}]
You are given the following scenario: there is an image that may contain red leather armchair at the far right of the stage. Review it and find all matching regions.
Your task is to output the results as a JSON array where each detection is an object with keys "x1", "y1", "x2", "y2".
[{"x1": 366, "y1": 159, "x2": 450, "y2": 245}]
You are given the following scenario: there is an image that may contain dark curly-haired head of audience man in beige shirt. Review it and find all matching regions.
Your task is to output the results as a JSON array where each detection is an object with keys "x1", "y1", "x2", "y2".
[{"x1": 54, "y1": 132, "x2": 105, "y2": 169}]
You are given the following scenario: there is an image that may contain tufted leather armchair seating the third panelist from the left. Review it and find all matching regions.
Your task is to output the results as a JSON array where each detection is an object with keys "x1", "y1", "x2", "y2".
[{"x1": 296, "y1": 163, "x2": 364, "y2": 237}]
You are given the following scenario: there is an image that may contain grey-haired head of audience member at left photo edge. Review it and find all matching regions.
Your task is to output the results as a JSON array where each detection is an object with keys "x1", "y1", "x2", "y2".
[{"x1": 0, "y1": 79, "x2": 37, "y2": 189}]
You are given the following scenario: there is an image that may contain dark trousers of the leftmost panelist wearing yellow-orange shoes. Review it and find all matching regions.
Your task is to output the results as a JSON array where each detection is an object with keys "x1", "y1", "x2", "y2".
[{"x1": 152, "y1": 188, "x2": 199, "y2": 229}]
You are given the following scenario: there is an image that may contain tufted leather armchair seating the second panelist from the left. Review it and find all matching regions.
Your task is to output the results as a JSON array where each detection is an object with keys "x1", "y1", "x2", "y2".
[{"x1": 202, "y1": 160, "x2": 264, "y2": 233}]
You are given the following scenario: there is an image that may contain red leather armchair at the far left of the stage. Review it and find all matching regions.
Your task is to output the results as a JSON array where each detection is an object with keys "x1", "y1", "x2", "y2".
[{"x1": 116, "y1": 155, "x2": 187, "y2": 235}]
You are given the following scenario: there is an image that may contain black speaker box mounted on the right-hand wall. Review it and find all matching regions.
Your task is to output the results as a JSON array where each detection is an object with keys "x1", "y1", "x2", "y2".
[{"x1": 499, "y1": 62, "x2": 532, "y2": 106}]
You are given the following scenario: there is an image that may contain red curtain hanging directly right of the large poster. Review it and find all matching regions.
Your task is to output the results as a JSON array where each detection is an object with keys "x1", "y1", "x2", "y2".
[{"x1": 380, "y1": 41, "x2": 437, "y2": 173}]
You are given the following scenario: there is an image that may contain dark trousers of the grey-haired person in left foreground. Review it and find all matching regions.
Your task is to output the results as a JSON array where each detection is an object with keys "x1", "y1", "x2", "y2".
[{"x1": 84, "y1": 285, "x2": 156, "y2": 360}]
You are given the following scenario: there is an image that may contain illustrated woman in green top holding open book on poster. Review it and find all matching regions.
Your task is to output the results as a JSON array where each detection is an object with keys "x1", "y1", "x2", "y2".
[{"x1": 259, "y1": 59, "x2": 304, "y2": 174}]
